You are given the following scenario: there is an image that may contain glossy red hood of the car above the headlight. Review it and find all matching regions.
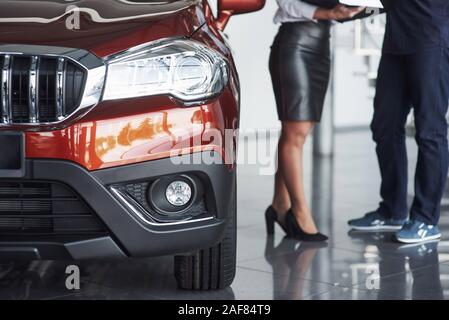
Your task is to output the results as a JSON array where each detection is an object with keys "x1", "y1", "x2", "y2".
[{"x1": 0, "y1": 0, "x2": 203, "y2": 57}]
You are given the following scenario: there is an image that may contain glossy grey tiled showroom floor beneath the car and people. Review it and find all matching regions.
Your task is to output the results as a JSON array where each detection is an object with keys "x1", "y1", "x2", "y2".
[{"x1": 0, "y1": 132, "x2": 449, "y2": 299}]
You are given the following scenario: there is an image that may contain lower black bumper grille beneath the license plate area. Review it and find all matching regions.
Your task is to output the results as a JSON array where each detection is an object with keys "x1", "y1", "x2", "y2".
[{"x1": 0, "y1": 181, "x2": 107, "y2": 235}]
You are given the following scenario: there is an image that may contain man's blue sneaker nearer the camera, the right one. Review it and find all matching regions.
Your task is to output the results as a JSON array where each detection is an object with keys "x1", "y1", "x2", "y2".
[{"x1": 396, "y1": 220, "x2": 441, "y2": 243}]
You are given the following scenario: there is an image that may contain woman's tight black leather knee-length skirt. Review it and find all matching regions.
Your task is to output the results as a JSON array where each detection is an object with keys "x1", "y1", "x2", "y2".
[{"x1": 270, "y1": 21, "x2": 331, "y2": 122}]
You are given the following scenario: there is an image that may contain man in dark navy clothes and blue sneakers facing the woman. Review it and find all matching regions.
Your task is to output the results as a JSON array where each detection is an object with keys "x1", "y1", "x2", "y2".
[{"x1": 349, "y1": 0, "x2": 449, "y2": 243}]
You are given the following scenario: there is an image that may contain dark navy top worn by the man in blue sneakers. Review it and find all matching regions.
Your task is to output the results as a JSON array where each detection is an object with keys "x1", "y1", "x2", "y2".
[{"x1": 383, "y1": 0, "x2": 449, "y2": 54}]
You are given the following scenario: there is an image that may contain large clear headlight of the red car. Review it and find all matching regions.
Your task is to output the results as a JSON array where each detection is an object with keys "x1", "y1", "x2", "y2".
[{"x1": 103, "y1": 39, "x2": 228, "y2": 102}]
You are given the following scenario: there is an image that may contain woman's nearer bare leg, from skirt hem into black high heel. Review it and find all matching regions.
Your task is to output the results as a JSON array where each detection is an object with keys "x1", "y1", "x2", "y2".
[{"x1": 278, "y1": 121, "x2": 318, "y2": 234}]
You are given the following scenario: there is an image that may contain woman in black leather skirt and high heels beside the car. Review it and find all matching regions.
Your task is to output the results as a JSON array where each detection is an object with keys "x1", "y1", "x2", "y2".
[{"x1": 265, "y1": 0, "x2": 362, "y2": 241}]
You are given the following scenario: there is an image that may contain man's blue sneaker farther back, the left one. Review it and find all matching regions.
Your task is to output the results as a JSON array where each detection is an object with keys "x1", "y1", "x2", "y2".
[{"x1": 348, "y1": 211, "x2": 406, "y2": 231}]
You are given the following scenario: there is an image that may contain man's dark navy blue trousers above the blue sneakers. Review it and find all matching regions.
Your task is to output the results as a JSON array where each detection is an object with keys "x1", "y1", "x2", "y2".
[{"x1": 371, "y1": 48, "x2": 449, "y2": 225}]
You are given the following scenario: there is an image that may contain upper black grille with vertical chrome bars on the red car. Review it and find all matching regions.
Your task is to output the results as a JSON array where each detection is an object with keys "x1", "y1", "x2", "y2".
[{"x1": 0, "y1": 54, "x2": 87, "y2": 124}]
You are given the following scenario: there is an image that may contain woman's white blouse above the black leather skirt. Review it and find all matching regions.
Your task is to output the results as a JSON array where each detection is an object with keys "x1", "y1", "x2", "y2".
[{"x1": 274, "y1": 0, "x2": 318, "y2": 23}]
